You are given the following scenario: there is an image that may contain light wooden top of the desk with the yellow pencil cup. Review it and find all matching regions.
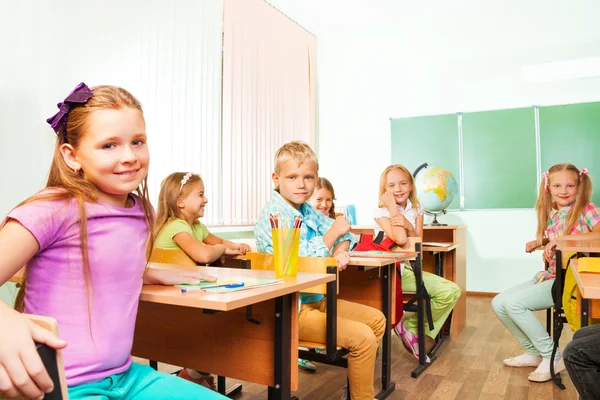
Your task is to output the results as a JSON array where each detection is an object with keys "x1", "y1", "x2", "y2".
[{"x1": 140, "y1": 263, "x2": 335, "y2": 311}]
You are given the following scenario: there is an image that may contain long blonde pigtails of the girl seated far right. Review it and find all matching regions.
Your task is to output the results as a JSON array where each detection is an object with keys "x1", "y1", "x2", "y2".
[{"x1": 535, "y1": 163, "x2": 592, "y2": 246}]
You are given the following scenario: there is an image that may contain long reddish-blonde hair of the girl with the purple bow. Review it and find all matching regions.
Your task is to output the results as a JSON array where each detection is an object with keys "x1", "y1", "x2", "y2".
[{"x1": 15, "y1": 86, "x2": 154, "y2": 312}]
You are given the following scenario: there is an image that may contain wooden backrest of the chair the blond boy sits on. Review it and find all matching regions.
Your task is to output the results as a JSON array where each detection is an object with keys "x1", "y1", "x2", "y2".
[{"x1": 246, "y1": 252, "x2": 340, "y2": 294}]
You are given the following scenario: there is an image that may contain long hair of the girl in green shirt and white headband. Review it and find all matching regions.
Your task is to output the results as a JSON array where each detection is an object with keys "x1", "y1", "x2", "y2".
[{"x1": 154, "y1": 172, "x2": 202, "y2": 237}]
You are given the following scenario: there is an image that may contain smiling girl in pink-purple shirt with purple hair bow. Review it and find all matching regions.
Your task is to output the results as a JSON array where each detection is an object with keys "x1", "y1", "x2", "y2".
[{"x1": 0, "y1": 83, "x2": 223, "y2": 400}]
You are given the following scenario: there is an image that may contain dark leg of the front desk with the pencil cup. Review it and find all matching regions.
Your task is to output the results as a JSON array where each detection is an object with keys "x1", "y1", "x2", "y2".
[{"x1": 269, "y1": 294, "x2": 295, "y2": 400}]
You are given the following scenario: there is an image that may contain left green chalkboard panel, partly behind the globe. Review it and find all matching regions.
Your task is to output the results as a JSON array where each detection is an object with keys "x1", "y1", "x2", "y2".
[{"x1": 391, "y1": 114, "x2": 460, "y2": 209}]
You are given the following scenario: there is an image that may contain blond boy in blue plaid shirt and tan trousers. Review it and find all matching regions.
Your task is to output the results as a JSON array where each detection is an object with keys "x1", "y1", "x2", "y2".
[{"x1": 254, "y1": 142, "x2": 386, "y2": 400}]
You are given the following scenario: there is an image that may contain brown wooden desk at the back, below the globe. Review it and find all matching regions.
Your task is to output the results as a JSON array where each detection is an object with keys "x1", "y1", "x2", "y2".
[{"x1": 351, "y1": 225, "x2": 467, "y2": 340}]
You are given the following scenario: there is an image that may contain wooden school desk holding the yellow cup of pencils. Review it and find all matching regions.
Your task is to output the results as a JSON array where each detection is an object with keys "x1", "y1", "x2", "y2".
[{"x1": 132, "y1": 263, "x2": 335, "y2": 400}]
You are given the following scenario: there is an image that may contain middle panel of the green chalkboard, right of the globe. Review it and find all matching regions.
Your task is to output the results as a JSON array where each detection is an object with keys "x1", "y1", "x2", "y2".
[{"x1": 462, "y1": 107, "x2": 537, "y2": 209}]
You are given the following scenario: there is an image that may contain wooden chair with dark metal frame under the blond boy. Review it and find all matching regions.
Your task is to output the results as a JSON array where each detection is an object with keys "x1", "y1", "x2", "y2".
[{"x1": 246, "y1": 252, "x2": 348, "y2": 368}]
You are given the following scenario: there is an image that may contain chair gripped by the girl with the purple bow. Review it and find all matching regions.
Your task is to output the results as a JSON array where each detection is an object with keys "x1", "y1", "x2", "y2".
[{"x1": 16, "y1": 314, "x2": 69, "y2": 400}]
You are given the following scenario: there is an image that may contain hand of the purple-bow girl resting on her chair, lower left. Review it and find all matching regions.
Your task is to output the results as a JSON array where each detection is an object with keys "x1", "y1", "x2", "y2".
[{"x1": 0, "y1": 308, "x2": 67, "y2": 399}]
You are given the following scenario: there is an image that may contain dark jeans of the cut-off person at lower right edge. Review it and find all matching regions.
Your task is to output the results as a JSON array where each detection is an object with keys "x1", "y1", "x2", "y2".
[{"x1": 563, "y1": 325, "x2": 600, "y2": 400}]
